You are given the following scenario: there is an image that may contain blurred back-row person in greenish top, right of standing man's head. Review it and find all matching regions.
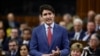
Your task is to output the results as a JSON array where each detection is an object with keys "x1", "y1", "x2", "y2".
[{"x1": 63, "y1": 13, "x2": 73, "y2": 31}]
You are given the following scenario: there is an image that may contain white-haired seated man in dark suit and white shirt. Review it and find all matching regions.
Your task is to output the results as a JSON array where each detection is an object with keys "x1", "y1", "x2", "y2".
[{"x1": 69, "y1": 18, "x2": 85, "y2": 41}]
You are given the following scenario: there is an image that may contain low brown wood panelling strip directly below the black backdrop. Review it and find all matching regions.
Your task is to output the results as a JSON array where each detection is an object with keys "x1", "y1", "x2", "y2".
[{"x1": 0, "y1": 16, "x2": 62, "y2": 27}]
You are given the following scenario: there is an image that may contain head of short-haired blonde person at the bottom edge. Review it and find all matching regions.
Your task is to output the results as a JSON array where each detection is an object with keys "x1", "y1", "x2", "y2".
[{"x1": 70, "y1": 42, "x2": 83, "y2": 56}]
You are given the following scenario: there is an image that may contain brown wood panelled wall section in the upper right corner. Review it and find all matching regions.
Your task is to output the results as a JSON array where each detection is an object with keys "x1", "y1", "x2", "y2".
[{"x1": 76, "y1": 0, "x2": 100, "y2": 18}]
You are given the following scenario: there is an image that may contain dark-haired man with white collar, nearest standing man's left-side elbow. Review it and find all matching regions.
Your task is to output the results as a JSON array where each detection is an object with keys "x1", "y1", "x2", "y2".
[{"x1": 22, "y1": 28, "x2": 32, "y2": 45}]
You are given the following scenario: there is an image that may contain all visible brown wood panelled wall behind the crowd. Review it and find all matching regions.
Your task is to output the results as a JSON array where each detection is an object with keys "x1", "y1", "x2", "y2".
[{"x1": 0, "y1": 0, "x2": 100, "y2": 27}]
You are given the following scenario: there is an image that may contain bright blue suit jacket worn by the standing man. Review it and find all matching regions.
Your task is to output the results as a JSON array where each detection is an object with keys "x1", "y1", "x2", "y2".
[{"x1": 30, "y1": 24, "x2": 69, "y2": 56}]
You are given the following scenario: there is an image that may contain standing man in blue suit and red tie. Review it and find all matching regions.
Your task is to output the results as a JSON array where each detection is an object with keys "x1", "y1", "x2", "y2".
[{"x1": 30, "y1": 5, "x2": 69, "y2": 56}]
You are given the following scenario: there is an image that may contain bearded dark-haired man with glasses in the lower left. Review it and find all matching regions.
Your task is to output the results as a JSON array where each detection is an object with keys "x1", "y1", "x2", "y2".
[{"x1": 6, "y1": 40, "x2": 19, "y2": 56}]
